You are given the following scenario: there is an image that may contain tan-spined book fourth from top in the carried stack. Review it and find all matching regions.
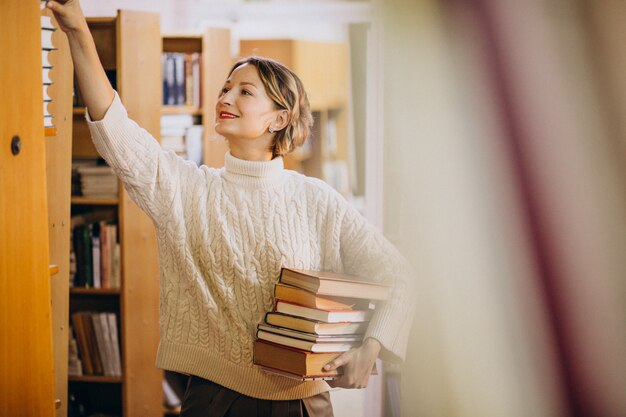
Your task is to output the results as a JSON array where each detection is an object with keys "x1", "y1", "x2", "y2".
[{"x1": 265, "y1": 312, "x2": 368, "y2": 336}]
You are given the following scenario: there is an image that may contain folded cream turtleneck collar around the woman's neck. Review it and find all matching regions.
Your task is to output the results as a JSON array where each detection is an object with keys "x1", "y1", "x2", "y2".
[{"x1": 224, "y1": 151, "x2": 284, "y2": 188}]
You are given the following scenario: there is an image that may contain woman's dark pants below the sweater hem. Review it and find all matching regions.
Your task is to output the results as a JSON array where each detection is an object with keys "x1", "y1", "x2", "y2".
[{"x1": 180, "y1": 375, "x2": 333, "y2": 417}]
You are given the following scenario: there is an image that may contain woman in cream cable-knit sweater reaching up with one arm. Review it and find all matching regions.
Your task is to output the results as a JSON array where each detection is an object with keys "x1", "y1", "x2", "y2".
[{"x1": 47, "y1": 0, "x2": 411, "y2": 416}]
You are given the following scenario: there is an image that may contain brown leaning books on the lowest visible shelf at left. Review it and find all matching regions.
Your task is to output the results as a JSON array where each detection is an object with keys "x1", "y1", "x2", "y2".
[{"x1": 68, "y1": 311, "x2": 122, "y2": 376}]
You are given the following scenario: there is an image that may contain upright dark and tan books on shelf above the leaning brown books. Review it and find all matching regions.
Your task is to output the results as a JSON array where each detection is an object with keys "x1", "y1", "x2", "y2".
[{"x1": 70, "y1": 216, "x2": 121, "y2": 288}]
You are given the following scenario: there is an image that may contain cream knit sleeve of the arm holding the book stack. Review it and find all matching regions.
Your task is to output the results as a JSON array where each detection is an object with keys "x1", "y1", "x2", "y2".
[{"x1": 340, "y1": 198, "x2": 415, "y2": 363}]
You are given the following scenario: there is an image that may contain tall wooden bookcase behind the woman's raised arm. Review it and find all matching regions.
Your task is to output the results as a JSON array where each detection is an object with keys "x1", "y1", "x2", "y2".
[{"x1": 66, "y1": 10, "x2": 163, "y2": 417}]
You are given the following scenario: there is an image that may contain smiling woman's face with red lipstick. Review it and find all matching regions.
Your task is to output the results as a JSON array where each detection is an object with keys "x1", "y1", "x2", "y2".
[{"x1": 215, "y1": 64, "x2": 280, "y2": 143}]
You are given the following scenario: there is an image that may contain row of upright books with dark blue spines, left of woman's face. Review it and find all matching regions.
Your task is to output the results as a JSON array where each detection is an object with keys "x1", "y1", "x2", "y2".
[{"x1": 161, "y1": 52, "x2": 201, "y2": 107}]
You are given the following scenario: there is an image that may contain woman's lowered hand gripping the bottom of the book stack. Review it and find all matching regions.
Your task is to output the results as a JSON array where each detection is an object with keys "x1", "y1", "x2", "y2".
[{"x1": 324, "y1": 338, "x2": 380, "y2": 388}]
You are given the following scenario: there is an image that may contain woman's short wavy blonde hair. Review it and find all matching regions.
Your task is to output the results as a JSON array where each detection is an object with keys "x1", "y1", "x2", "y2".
[{"x1": 227, "y1": 56, "x2": 313, "y2": 157}]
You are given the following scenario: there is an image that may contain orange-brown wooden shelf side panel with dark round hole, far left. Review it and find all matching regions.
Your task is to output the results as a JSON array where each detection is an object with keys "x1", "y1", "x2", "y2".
[{"x1": 0, "y1": 1, "x2": 59, "y2": 417}]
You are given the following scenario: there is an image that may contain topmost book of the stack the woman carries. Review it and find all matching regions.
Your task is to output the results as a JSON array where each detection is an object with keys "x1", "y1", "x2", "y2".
[{"x1": 280, "y1": 268, "x2": 390, "y2": 300}]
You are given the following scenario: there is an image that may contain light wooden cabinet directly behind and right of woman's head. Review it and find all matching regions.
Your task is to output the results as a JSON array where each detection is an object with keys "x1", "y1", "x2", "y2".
[{"x1": 239, "y1": 39, "x2": 352, "y2": 188}]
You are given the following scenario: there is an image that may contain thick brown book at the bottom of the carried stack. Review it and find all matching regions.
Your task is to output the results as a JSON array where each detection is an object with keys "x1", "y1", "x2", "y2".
[{"x1": 254, "y1": 340, "x2": 341, "y2": 379}]
